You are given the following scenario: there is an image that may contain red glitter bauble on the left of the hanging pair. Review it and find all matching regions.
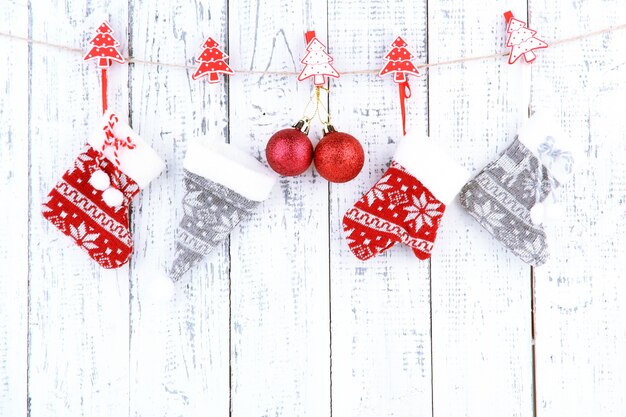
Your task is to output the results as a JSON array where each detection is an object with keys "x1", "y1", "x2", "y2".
[{"x1": 265, "y1": 128, "x2": 313, "y2": 177}]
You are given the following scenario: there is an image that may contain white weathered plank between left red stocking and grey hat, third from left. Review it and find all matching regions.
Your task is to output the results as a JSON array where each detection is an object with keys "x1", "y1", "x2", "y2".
[{"x1": 130, "y1": 0, "x2": 230, "y2": 417}]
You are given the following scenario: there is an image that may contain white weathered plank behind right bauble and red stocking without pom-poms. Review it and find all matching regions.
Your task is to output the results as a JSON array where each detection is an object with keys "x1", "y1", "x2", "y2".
[{"x1": 328, "y1": 0, "x2": 431, "y2": 417}]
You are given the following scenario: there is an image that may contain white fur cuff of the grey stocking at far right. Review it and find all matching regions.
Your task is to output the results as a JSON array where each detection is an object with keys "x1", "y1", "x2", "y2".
[{"x1": 518, "y1": 116, "x2": 580, "y2": 184}]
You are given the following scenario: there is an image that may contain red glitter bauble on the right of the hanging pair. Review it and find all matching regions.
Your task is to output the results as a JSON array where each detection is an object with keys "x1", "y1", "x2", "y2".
[{"x1": 314, "y1": 132, "x2": 365, "y2": 182}]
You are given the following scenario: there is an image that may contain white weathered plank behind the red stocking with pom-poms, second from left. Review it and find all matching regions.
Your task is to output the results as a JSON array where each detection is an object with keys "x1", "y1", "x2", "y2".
[{"x1": 29, "y1": 4, "x2": 129, "y2": 417}]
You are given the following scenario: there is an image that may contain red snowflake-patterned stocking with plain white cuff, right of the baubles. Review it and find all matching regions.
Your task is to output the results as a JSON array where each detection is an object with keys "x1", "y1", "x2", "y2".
[{"x1": 343, "y1": 133, "x2": 468, "y2": 261}]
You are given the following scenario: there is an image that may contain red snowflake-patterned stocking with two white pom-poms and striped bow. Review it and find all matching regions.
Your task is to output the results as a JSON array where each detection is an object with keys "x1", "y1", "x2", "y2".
[{"x1": 42, "y1": 112, "x2": 165, "y2": 268}]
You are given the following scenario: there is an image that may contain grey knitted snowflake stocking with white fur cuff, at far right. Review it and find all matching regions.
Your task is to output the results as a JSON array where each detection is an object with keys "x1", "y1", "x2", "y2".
[{"x1": 459, "y1": 120, "x2": 574, "y2": 266}]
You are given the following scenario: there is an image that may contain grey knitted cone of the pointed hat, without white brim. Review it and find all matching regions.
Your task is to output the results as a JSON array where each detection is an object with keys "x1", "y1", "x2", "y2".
[{"x1": 170, "y1": 170, "x2": 259, "y2": 281}]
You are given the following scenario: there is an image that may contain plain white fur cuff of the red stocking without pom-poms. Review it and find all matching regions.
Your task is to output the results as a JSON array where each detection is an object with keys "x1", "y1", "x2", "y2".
[{"x1": 393, "y1": 132, "x2": 469, "y2": 205}]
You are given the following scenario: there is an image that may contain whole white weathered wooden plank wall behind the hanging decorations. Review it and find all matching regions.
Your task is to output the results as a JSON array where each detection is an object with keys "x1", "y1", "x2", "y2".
[{"x1": 0, "y1": 0, "x2": 626, "y2": 417}]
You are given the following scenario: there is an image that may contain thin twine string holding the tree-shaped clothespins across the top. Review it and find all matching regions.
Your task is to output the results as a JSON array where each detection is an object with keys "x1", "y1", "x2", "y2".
[{"x1": 0, "y1": 23, "x2": 626, "y2": 76}]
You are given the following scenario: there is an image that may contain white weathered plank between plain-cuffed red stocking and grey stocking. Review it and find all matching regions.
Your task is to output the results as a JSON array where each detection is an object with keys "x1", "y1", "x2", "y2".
[{"x1": 428, "y1": 0, "x2": 533, "y2": 416}]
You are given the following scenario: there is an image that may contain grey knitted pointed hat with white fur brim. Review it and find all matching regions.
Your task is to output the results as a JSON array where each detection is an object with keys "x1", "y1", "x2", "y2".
[{"x1": 169, "y1": 139, "x2": 275, "y2": 282}]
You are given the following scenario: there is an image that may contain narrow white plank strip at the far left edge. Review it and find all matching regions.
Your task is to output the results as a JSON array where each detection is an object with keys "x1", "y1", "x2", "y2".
[{"x1": 0, "y1": 1, "x2": 28, "y2": 416}]
